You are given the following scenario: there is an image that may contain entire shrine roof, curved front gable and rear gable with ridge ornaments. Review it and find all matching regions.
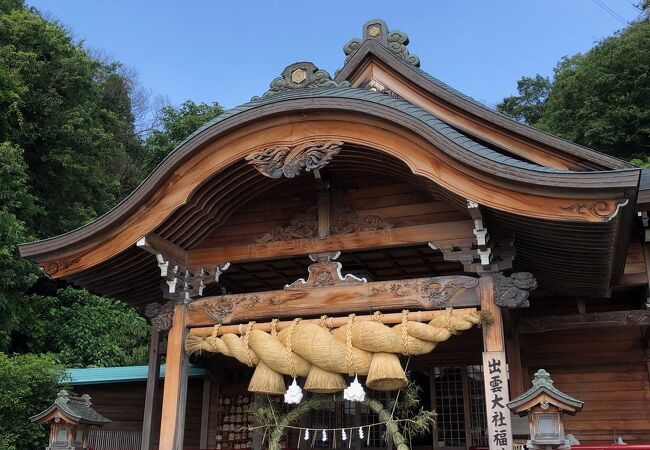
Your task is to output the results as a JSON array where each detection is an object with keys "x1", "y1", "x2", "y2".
[{"x1": 20, "y1": 21, "x2": 640, "y2": 302}]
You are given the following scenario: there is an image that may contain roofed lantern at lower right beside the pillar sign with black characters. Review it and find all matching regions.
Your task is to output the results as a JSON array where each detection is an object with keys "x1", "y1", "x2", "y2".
[{"x1": 508, "y1": 369, "x2": 584, "y2": 449}]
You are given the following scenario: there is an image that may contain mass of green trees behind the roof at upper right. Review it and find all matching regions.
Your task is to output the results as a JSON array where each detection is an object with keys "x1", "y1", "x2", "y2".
[{"x1": 497, "y1": 19, "x2": 650, "y2": 161}]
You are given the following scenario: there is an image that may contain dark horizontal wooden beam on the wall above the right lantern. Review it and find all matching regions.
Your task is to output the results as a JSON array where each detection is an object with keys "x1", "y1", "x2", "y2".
[{"x1": 517, "y1": 309, "x2": 650, "y2": 333}]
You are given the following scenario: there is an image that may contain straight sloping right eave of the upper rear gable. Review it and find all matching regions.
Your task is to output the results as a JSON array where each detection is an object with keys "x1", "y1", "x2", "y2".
[{"x1": 336, "y1": 39, "x2": 633, "y2": 171}]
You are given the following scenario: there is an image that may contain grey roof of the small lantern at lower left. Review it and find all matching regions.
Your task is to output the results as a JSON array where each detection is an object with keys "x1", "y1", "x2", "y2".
[{"x1": 30, "y1": 389, "x2": 111, "y2": 426}]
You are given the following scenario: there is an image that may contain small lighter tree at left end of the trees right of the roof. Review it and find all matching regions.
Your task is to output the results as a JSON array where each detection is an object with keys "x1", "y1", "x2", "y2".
[{"x1": 497, "y1": 74, "x2": 552, "y2": 125}]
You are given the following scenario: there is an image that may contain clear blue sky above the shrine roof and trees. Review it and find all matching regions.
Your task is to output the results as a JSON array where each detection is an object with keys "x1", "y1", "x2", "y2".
[{"x1": 27, "y1": 0, "x2": 639, "y2": 107}]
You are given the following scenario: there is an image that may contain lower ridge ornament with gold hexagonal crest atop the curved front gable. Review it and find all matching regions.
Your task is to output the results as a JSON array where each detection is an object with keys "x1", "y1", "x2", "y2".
[{"x1": 251, "y1": 61, "x2": 350, "y2": 101}]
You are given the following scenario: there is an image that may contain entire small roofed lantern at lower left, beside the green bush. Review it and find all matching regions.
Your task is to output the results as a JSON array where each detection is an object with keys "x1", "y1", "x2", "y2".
[{"x1": 30, "y1": 390, "x2": 110, "y2": 450}]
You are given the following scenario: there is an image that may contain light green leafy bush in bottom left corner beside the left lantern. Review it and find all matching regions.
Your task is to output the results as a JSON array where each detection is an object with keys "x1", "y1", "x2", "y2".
[{"x1": 0, "y1": 353, "x2": 63, "y2": 450}]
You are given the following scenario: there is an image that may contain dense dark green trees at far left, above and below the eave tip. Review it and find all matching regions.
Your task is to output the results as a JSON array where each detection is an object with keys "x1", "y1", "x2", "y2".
[{"x1": 0, "y1": 0, "x2": 149, "y2": 366}]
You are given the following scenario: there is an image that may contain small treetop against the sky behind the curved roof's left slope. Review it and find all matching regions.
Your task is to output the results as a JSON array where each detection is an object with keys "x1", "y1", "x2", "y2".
[{"x1": 144, "y1": 100, "x2": 223, "y2": 173}]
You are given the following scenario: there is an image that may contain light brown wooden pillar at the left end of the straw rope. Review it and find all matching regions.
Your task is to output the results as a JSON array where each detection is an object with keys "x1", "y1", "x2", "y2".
[{"x1": 158, "y1": 304, "x2": 188, "y2": 450}]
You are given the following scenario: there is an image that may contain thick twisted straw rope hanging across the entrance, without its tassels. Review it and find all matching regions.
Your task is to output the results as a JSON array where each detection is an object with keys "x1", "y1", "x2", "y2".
[{"x1": 186, "y1": 309, "x2": 489, "y2": 390}]
